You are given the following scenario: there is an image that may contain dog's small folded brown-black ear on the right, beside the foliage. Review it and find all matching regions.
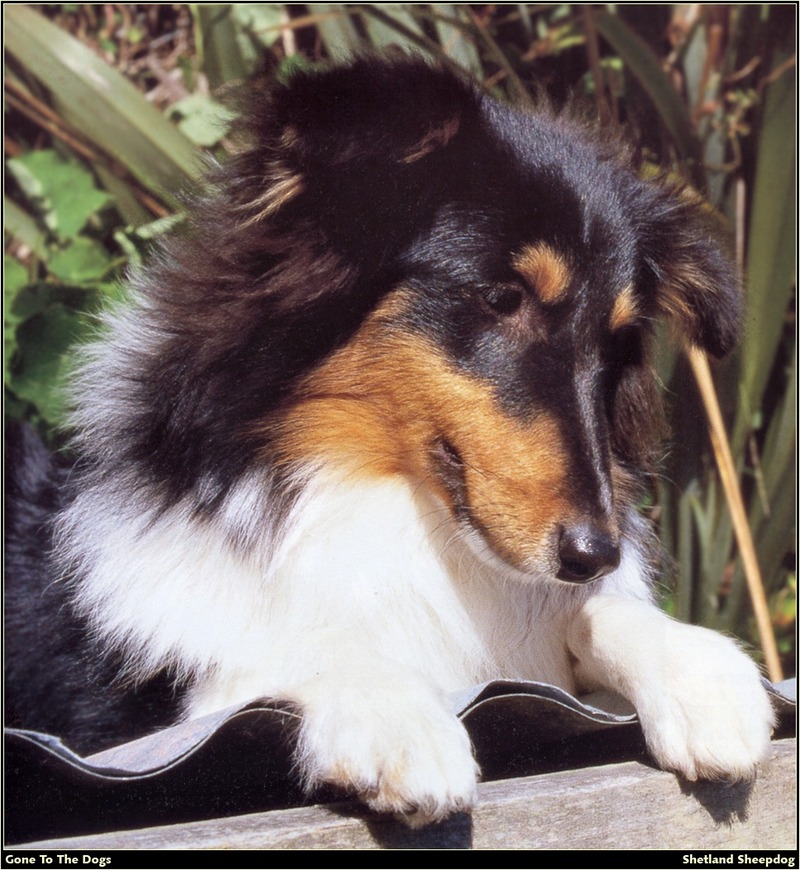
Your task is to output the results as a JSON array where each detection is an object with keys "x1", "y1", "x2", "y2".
[{"x1": 644, "y1": 190, "x2": 744, "y2": 357}]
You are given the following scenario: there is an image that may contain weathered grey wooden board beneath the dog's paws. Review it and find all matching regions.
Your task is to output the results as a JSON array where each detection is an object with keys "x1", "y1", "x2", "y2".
[{"x1": 17, "y1": 740, "x2": 797, "y2": 850}]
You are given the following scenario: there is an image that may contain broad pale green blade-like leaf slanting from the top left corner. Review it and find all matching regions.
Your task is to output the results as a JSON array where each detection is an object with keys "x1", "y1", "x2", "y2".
[{"x1": 4, "y1": 5, "x2": 201, "y2": 205}]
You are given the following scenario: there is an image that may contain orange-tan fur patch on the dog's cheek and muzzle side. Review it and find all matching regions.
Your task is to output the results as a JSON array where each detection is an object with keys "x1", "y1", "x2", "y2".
[{"x1": 269, "y1": 299, "x2": 570, "y2": 570}]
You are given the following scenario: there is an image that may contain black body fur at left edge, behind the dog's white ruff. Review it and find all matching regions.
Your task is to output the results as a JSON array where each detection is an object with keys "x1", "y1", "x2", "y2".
[{"x1": 4, "y1": 424, "x2": 180, "y2": 753}]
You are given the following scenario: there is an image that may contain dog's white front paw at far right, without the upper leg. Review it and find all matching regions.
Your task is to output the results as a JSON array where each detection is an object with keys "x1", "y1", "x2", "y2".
[{"x1": 635, "y1": 623, "x2": 774, "y2": 780}]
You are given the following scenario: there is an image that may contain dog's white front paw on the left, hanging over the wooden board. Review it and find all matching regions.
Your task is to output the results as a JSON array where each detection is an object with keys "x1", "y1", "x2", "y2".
[{"x1": 298, "y1": 685, "x2": 478, "y2": 828}]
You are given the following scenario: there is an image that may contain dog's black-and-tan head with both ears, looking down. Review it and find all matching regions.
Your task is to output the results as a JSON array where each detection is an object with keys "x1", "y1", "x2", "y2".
[{"x1": 164, "y1": 59, "x2": 740, "y2": 582}]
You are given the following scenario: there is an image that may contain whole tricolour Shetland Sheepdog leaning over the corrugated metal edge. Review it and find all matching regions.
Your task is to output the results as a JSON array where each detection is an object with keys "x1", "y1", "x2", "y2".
[{"x1": 7, "y1": 57, "x2": 773, "y2": 826}]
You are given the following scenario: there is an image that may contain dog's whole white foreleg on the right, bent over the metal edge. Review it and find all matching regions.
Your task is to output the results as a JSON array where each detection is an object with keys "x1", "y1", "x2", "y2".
[{"x1": 568, "y1": 593, "x2": 774, "y2": 780}]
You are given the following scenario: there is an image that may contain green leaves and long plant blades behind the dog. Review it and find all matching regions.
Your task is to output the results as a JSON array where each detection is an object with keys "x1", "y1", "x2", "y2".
[{"x1": 4, "y1": 3, "x2": 797, "y2": 673}]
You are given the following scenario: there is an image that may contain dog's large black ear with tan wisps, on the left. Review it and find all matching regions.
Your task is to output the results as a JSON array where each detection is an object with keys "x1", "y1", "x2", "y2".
[{"x1": 236, "y1": 56, "x2": 481, "y2": 258}]
